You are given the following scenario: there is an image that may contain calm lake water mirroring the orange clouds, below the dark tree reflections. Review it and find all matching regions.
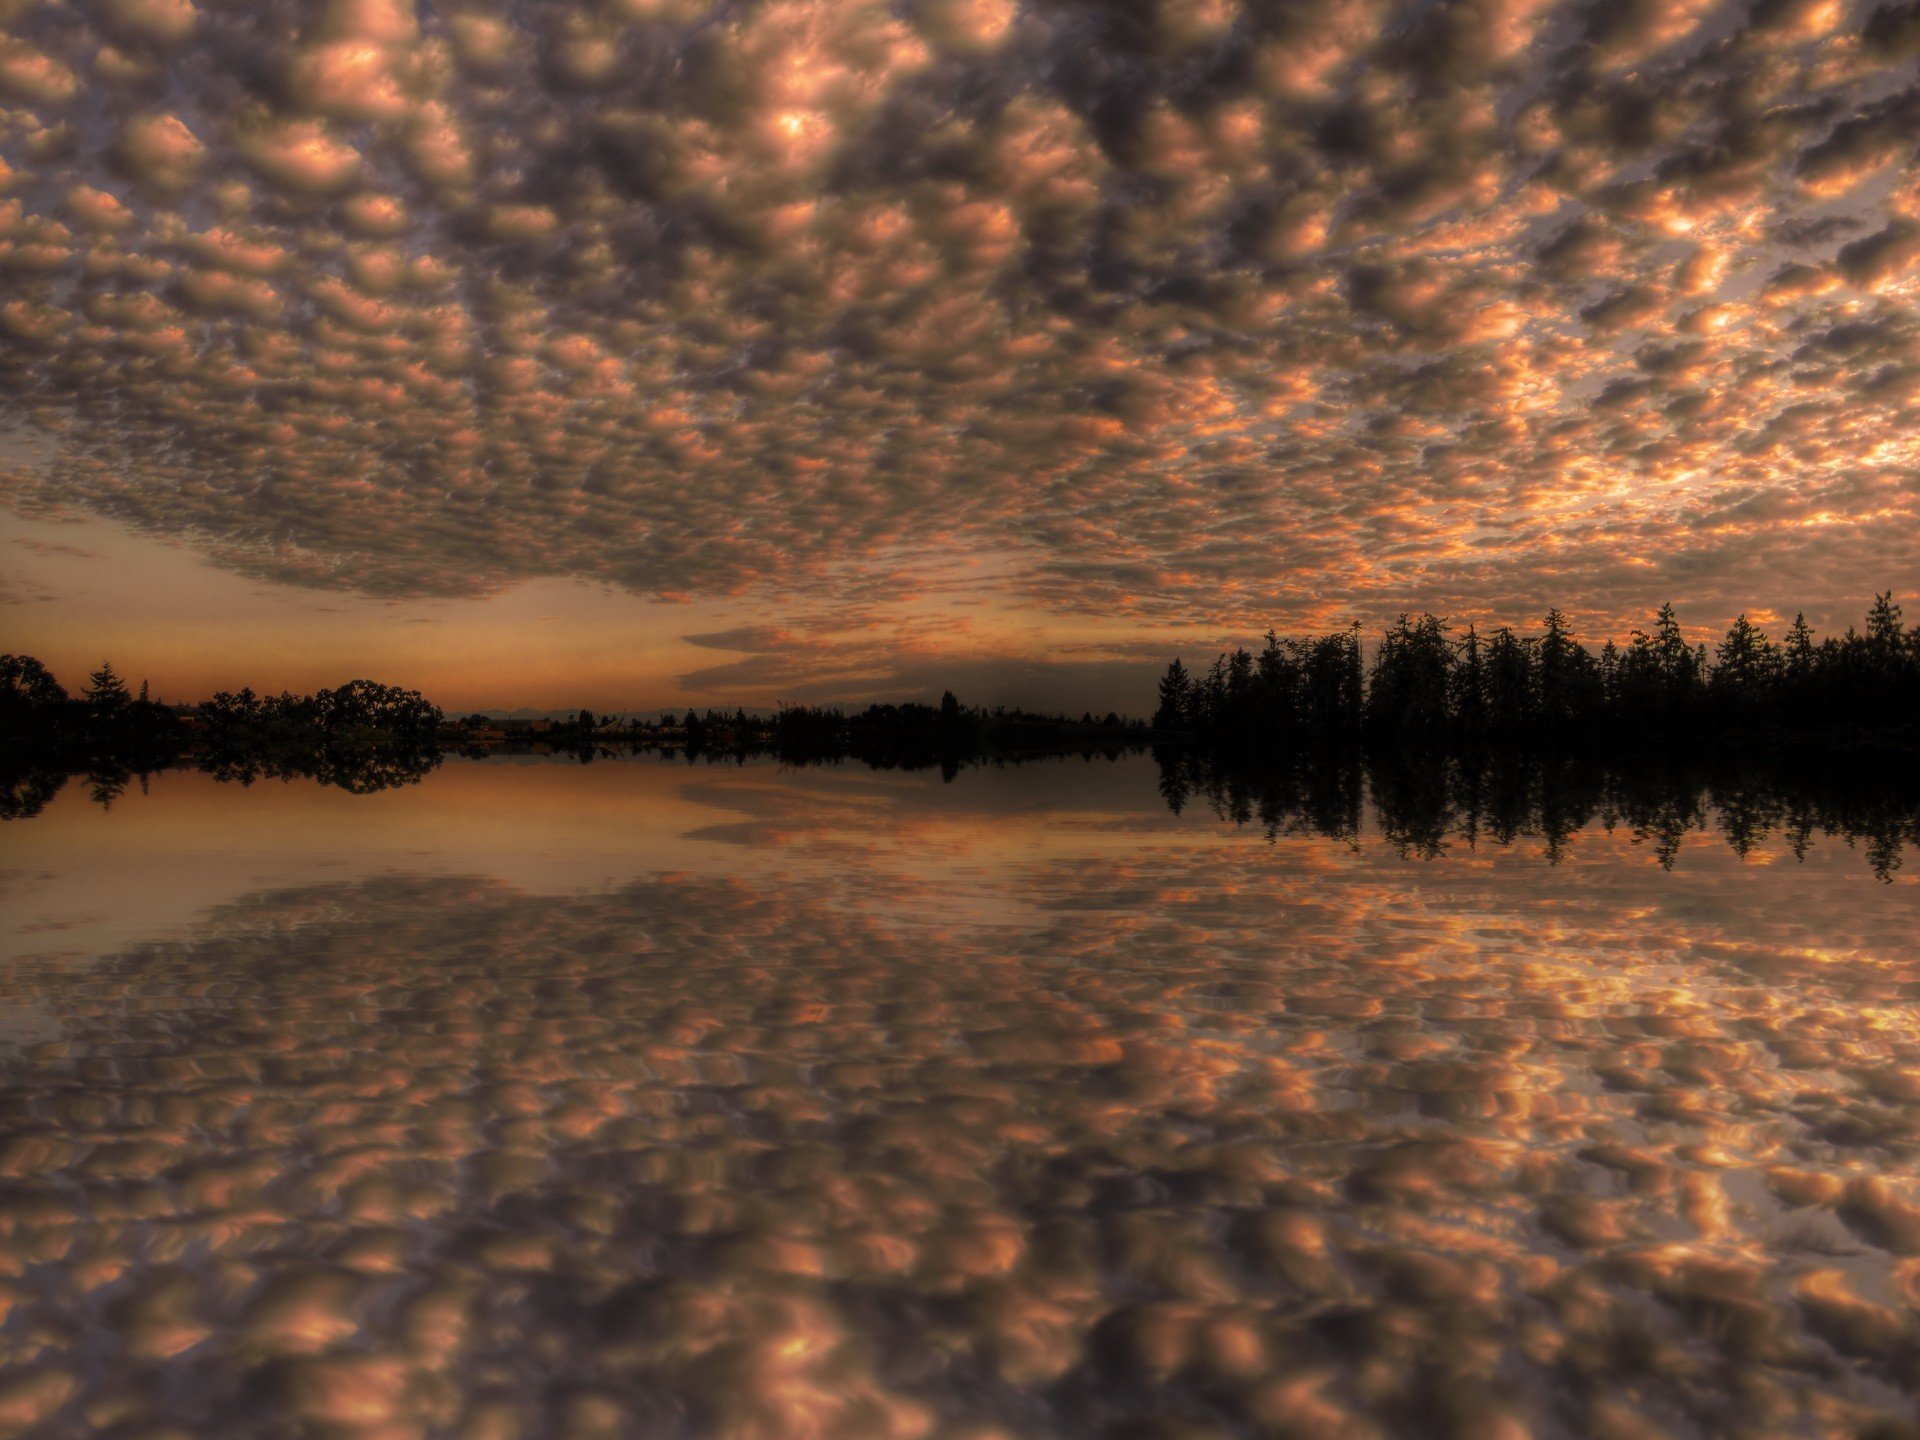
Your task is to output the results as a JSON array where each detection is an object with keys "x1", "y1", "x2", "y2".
[{"x1": 0, "y1": 760, "x2": 1920, "y2": 1440}]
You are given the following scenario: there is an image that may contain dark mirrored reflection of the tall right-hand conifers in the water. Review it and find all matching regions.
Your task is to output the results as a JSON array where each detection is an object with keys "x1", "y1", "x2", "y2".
[{"x1": 1154, "y1": 745, "x2": 1920, "y2": 879}]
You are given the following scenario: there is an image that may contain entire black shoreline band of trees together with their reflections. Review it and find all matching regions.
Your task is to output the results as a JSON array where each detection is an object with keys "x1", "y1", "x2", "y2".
[{"x1": 0, "y1": 593, "x2": 1920, "y2": 877}]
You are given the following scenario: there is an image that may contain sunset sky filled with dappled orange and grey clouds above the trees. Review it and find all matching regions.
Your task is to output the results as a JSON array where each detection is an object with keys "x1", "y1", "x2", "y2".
[{"x1": 0, "y1": 0, "x2": 1920, "y2": 712}]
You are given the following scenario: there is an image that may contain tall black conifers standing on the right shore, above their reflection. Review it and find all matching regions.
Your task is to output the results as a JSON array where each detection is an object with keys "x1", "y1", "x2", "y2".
[{"x1": 1154, "y1": 593, "x2": 1920, "y2": 751}]
